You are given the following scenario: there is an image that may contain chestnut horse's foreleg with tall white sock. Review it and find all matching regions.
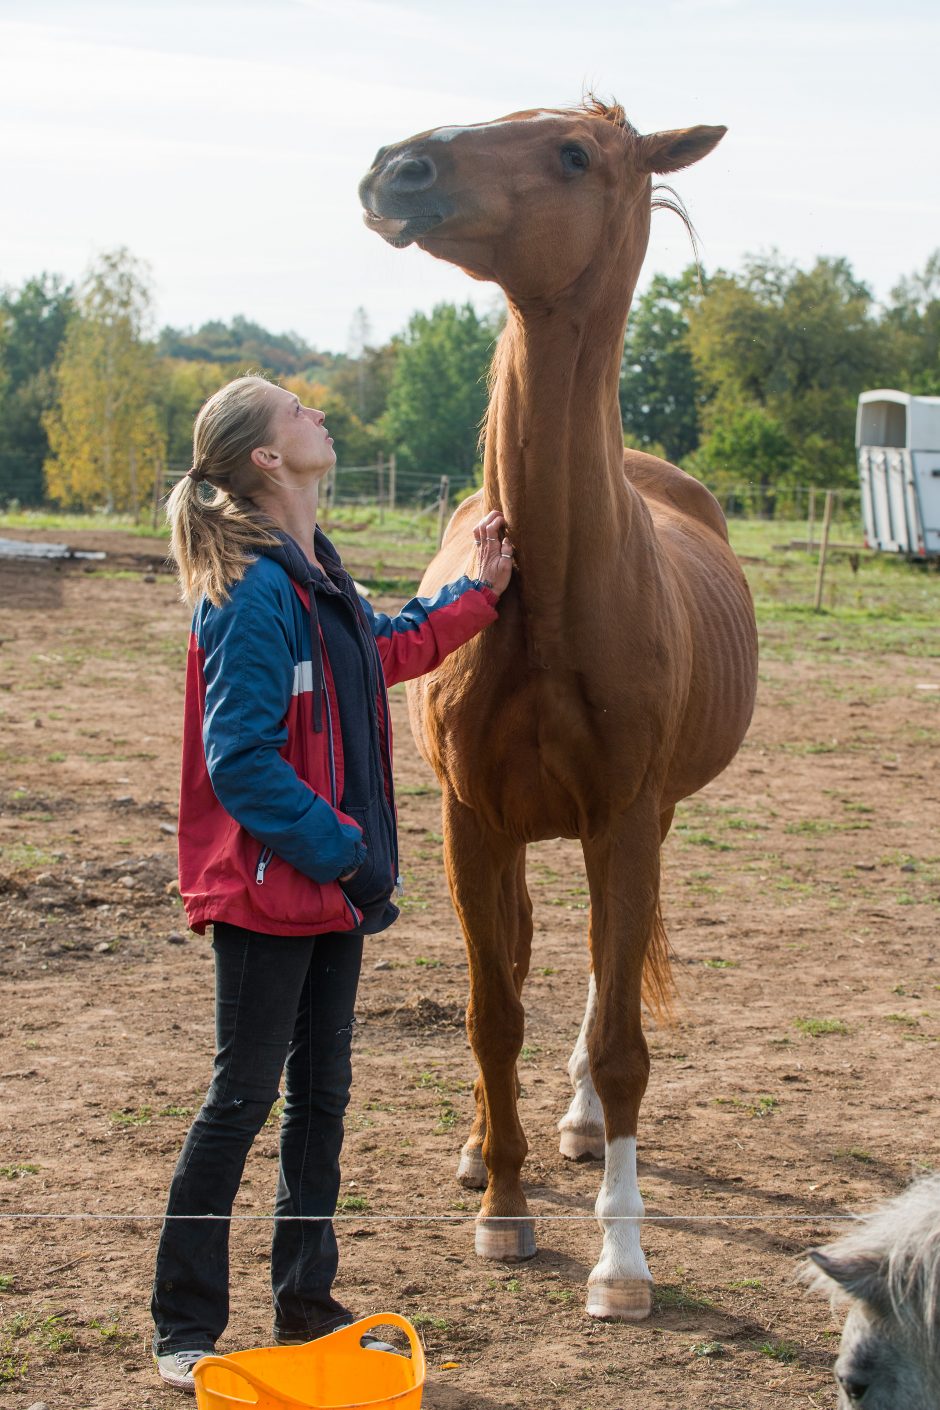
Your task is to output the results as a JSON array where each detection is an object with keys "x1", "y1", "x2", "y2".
[{"x1": 585, "y1": 809, "x2": 660, "y2": 1321}]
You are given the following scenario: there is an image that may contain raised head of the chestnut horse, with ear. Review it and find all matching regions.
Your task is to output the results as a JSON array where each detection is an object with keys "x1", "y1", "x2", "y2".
[{"x1": 359, "y1": 103, "x2": 726, "y2": 300}]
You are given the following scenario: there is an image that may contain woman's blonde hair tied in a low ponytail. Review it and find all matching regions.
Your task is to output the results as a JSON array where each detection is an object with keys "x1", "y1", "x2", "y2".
[{"x1": 166, "y1": 375, "x2": 278, "y2": 606}]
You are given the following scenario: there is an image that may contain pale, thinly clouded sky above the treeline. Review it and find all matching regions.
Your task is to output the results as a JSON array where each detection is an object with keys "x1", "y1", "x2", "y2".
[{"x1": 0, "y1": 0, "x2": 940, "y2": 351}]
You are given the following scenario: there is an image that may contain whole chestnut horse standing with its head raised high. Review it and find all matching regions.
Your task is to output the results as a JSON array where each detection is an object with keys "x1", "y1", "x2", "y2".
[{"x1": 359, "y1": 103, "x2": 757, "y2": 1318}]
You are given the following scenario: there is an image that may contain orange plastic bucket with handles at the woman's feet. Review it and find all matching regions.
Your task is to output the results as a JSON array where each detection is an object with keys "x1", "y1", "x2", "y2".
[{"x1": 193, "y1": 1313, "x2": 424, "y2": 1410}]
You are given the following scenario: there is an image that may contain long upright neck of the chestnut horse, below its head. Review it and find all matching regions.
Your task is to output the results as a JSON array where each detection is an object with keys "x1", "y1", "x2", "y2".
[{"x1": 483, "y1": 293, "x2": 659, "y2": 666}]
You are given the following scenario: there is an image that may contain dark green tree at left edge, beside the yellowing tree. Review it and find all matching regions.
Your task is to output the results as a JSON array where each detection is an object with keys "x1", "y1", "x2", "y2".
[{"x1": 0, "y1": 274, "x2": 73, "y2": 503}]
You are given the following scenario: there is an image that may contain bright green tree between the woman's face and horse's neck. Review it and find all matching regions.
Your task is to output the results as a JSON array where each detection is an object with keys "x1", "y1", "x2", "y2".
[{"x1": 381, "y1": 303, "x2": 496, "y2": 482}]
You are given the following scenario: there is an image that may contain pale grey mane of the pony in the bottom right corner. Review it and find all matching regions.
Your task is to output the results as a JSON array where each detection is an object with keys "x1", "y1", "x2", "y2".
[{"x1": 800, "y1": 1172, "x2": 940, "y2": 1351}]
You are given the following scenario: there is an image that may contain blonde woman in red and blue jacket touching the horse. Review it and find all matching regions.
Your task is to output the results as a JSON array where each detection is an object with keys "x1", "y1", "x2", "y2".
[{"x1": 152, "y1": 376, "x2": 513, "y2": 1390}]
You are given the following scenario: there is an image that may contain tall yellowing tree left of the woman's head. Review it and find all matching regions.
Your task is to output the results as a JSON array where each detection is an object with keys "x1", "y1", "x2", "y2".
[{"x1": 44, "y1": 250, "x2": 165, "y2": 513}]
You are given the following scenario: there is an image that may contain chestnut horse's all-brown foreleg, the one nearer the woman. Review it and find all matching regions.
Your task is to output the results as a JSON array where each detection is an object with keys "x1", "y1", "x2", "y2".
[{"x1": 443, "y1": 791, "x2": 536, "y2": 1259}]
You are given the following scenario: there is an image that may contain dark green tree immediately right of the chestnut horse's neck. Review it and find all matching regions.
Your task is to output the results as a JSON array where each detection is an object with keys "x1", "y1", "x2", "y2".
[{"x1": 620, "y1": 265, "x2": 705, "y2": 461}]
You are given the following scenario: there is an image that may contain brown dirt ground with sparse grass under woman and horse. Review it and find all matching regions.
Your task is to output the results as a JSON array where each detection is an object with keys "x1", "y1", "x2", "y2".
[{"x1": 0, "y1": 534, "x2": 940, "y2": 1410}]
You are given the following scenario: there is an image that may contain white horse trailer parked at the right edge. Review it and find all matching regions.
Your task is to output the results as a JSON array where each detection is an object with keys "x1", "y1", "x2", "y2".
[{"x1": 855, "y1": 389, "x2": 940, "y2": 558}]
